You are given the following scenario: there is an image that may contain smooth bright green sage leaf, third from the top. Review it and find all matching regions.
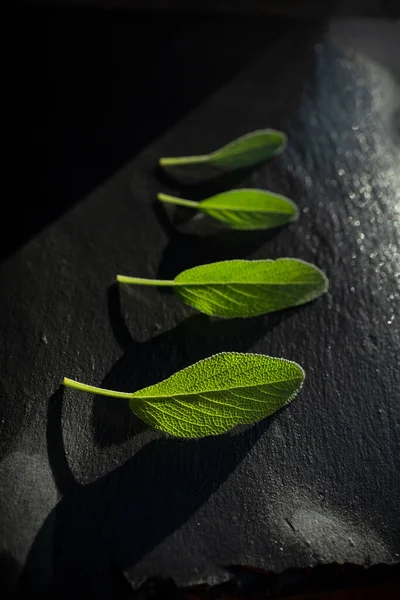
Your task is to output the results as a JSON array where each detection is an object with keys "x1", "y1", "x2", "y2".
[{"x1": 117, "y1": 258, "x2": 329, "y2": 318}]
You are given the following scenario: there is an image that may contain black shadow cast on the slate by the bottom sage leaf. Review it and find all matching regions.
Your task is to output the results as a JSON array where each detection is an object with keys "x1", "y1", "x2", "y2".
[{"x1": 19, "y1": 366, "x2": 273, "y2": 598}]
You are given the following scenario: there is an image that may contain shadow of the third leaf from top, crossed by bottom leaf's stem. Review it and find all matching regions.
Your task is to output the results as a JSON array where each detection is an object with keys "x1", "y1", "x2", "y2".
[{"x1": 92, "y1": 284, "x2": 293, "y2": 448}]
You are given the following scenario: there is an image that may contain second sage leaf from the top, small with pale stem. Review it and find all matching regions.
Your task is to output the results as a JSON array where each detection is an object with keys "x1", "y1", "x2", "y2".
[{"x1": 157, "y1": 189, "x2": 299, "y2": 229}]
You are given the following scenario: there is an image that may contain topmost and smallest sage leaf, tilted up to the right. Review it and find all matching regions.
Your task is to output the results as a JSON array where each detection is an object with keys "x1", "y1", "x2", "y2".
[{"x1": 160, "y1": 129, "x2": 286, "y2": 171}]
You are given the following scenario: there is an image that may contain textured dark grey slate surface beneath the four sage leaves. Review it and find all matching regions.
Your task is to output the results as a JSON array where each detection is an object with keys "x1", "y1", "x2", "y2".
[{"x1": 0, "y1": 9, "x2": 400, "y2": 598}]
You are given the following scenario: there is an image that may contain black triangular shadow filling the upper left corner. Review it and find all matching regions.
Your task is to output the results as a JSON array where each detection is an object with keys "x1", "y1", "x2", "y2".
[{"x1": 7, "y1": 6, "x2": 287, "y2": 259}]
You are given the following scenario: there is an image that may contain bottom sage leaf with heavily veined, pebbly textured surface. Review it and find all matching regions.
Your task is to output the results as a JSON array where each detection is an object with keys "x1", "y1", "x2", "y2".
[{"x1": 64, "y1": 352, "x2": 305, "y2": 438}]
